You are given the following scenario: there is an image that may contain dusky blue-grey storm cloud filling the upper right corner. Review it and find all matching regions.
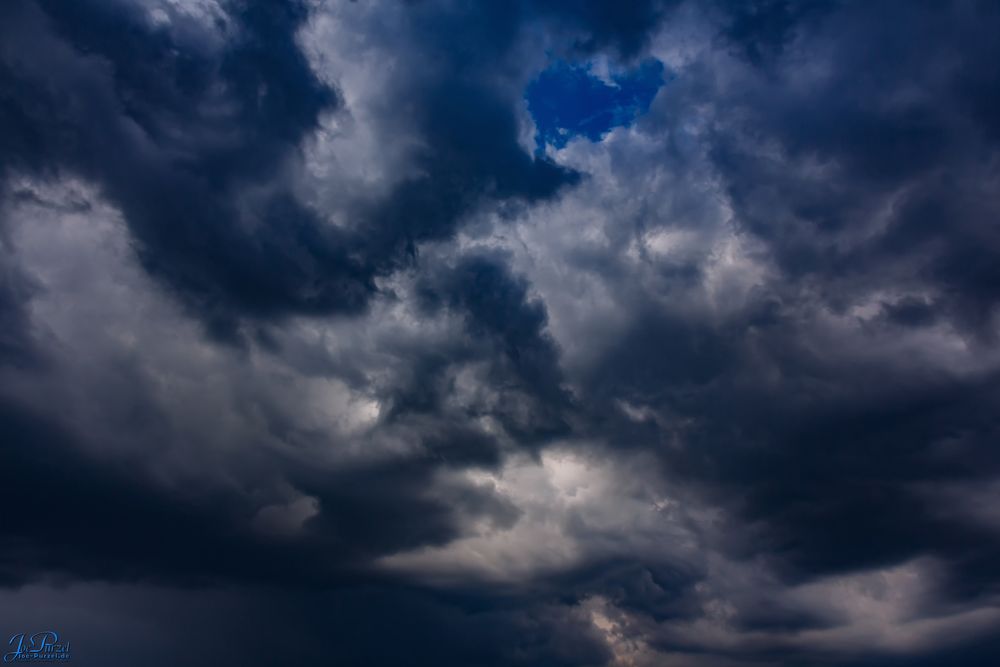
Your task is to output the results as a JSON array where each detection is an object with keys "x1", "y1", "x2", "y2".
[{"x1": 717, "y1": 3, "x2": 1000, "y2": 334}]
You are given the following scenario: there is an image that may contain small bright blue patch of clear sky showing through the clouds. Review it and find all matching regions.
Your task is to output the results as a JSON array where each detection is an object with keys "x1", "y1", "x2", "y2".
[{"x1": 524, "y1": 59, "x2": 665, "y2": 152}]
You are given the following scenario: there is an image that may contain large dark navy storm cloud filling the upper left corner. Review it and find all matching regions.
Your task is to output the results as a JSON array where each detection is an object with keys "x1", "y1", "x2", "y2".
[{"x1": 4, "y1": 2, "x2": 371, "y2": 340}]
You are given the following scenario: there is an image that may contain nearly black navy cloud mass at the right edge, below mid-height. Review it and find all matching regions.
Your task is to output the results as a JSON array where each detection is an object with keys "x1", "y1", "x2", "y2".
[{"x1": 648, "y1": 334, "x2": 1000, "y2": 590}]
